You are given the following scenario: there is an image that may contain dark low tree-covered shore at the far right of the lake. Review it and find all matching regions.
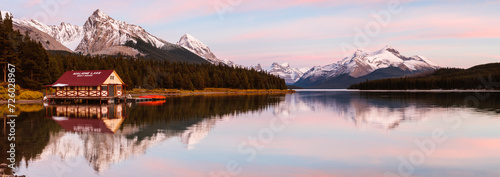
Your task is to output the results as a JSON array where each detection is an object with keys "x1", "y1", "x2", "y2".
[{"x1": 350, "y1": 63, "x2": 500, "y2": 90}]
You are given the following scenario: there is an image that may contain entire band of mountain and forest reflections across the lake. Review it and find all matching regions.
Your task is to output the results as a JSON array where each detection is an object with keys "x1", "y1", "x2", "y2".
[{"x1": 0, "y1": 91, "x2": 500, "y2": 177}]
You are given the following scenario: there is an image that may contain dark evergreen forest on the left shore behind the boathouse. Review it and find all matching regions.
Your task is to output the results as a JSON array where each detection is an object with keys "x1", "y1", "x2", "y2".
[{"x1": 0, "y1": 12, "x2": 287, "y2": 90}]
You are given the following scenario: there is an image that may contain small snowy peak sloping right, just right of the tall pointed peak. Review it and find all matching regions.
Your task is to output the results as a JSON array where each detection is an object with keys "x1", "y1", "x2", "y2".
[{"x1": 177, "y1": 34, "x2": 234, "y2": 66}]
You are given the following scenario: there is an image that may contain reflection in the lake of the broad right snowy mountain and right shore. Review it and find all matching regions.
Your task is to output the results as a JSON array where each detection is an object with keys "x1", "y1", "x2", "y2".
[{"x1": 274, "y1": 91, "x2": 500, "y2": 130}]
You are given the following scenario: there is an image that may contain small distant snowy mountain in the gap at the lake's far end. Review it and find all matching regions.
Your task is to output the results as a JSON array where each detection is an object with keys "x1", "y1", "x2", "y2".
[{"x1": 250, "y1": 62, "x2": 309, "y2": 84}]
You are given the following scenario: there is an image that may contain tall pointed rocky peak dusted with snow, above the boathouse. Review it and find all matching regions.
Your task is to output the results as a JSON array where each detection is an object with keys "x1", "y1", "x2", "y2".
[{"x1": 75, "y1": 9, "x2": 174, "y2": 55}]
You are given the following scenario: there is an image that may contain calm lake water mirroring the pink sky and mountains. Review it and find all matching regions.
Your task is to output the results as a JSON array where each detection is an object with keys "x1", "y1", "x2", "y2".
[{"x1": 0, "y1": 90, "x2": 500, "y2": 177}]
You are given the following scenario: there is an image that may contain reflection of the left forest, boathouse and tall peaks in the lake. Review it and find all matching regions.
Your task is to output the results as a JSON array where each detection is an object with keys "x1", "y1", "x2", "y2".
[{"x1": 0, "y1": 95, "x2": 284, "y2": 172}]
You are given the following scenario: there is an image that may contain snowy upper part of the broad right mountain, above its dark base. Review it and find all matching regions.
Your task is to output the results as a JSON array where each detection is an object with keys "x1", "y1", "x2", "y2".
[{"x1": 298, "y1": 46, "x2": 439, "y2": 86}]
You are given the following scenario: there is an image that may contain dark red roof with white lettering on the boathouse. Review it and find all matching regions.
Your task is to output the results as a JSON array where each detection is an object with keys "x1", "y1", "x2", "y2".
[{"x1": 47, "y1": 70, "x2": 114, "y2": 87}]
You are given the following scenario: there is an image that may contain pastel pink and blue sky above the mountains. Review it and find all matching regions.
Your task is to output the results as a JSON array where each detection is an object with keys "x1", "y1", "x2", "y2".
[{"x1": 0, "y1": 0, "x2": 500, "y2": 67}]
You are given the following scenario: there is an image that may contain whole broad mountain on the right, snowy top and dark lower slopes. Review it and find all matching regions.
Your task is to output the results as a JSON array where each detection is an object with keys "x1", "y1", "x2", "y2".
[{"x1": 294, "y1": 46, "x2": 439, "y2": 88}]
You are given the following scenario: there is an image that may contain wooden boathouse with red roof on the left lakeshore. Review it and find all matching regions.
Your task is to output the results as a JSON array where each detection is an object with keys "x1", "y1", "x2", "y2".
[{"x1": 46, "y1": 70, "x2": 126, "y2": 102}]
